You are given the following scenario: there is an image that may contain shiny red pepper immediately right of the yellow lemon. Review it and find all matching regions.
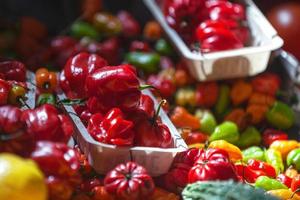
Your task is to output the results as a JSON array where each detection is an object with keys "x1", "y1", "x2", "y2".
[{"x1": 31, "y1": 141, "x2": 81, "y2": 200}]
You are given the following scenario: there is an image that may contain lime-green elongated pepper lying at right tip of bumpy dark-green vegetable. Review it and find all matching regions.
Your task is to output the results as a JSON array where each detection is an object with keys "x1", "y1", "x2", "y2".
[{"x1": 254, "y1": 176, "x2": 288, "y2": 191}]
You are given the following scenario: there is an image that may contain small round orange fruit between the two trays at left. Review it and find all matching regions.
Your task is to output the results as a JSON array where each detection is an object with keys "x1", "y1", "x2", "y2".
[{"x1": 35, "y1": 68, "x2": 57, "y2": 93}]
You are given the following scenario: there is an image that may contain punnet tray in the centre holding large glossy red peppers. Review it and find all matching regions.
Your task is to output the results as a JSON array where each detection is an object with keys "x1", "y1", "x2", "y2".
[{"x1": 58, "y1": 90, "x2": 187, "y2": 176}]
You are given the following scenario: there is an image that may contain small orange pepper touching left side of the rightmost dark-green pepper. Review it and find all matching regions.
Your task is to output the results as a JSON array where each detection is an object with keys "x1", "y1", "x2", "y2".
[{"x1": 246, "y1": 104, "x2": 269, "y2": 124}]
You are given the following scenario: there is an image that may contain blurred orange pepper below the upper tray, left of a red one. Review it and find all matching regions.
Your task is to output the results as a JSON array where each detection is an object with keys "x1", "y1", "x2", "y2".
[{"x1": 230, "y1": 80, "x2": 253, "y2": 106}]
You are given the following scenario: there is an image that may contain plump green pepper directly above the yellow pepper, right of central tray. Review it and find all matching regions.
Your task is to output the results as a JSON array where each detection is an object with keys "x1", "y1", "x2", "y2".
[{"x1": 209, "y1": 121, "x2": 239, "y2": 143}]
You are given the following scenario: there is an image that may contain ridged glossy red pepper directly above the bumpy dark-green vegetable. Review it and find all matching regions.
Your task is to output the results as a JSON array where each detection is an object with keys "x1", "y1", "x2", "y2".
[{"x1": 188, "y1": 149, "x2": 238, "y2": 183}]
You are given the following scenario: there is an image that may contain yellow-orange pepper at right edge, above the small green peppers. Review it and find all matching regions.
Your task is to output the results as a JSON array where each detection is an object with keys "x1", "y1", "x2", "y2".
[{"x1": 270, "y1": 140, "x2": 298, "y2": 160}]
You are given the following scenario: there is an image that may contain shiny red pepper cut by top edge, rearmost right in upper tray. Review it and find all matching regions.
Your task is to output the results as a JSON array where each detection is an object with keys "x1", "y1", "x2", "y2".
[{"x1": 205, "y1": 1, "x2": 246, "y2": 21}]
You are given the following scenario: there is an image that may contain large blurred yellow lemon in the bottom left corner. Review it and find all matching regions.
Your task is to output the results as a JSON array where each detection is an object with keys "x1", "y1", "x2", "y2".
[{"x1": 0, "y1": 153, "x2": 47, "y2": 200}]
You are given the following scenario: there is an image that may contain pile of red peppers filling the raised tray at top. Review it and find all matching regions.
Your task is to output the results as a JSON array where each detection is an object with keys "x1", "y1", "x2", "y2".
[{"x1": 163, "y1": 0, "x2": 250, "y2": 53}]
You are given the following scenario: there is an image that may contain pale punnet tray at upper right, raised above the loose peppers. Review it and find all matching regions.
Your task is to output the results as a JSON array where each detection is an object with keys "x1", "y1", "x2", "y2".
[{"x1": 143, "y1": 0, "x2": 283, "y2": 81}]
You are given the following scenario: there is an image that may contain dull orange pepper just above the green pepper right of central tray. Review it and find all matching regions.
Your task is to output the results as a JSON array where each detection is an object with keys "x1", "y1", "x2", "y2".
[{"x1": 224, "y1": 108, "x2": 251, "y2": 130}]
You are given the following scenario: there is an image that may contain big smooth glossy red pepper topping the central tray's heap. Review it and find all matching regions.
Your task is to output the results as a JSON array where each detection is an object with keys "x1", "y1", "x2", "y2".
[{"x1": 86, "y1": 65, "x2": 141, "y2": 112}]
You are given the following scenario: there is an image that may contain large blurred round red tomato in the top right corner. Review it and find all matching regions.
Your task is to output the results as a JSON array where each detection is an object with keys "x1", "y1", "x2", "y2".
[{"x1": 267, "y1": 1, "x2": 300, "y2": 59}]
